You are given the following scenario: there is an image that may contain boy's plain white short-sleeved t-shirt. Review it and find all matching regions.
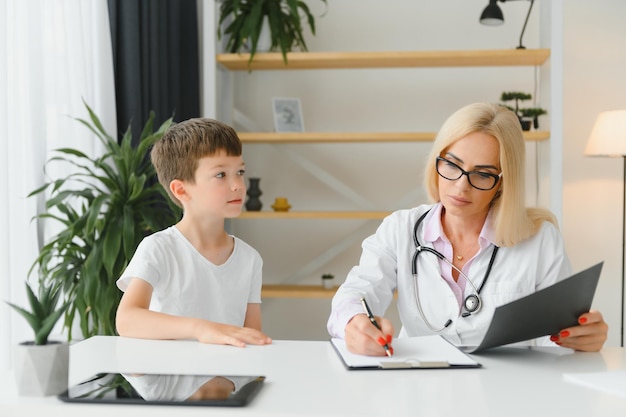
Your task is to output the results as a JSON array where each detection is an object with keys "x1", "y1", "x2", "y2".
[{"x1": 117, "y1": 226, "x2": 263, "y2": 326}]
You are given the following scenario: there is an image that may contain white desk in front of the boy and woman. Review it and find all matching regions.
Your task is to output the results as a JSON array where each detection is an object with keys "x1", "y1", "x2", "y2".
[{"x1": 0, "y1": 336, "x2": 626, "y2": 417}]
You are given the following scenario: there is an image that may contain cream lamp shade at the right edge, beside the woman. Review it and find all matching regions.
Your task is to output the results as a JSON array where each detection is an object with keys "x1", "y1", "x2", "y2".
[{"x1": 585, "y1": 110, "x2": 626, "y2": 157}]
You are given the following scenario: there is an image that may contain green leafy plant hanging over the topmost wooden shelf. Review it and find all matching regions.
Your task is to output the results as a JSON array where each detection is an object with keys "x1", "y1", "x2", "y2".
[{"x1": 217, "y1": 0, "x2": 326, "y2": 64}]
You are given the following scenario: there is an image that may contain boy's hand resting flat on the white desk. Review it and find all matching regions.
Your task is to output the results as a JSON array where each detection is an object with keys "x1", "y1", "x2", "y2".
[{"x1": 196, "y1": 320, "x2": 272, "y2": 347}]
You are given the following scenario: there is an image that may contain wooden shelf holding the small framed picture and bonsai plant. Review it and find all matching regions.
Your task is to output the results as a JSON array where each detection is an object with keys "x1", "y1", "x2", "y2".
[{"x1": 238, "y1": 130, "x2": 550, "y2": 144}]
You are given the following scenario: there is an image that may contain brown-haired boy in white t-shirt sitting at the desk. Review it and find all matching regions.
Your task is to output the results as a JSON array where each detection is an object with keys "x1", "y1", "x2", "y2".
[{"x1": 116, "y1": 118, "x2": 272, "y2": 347}]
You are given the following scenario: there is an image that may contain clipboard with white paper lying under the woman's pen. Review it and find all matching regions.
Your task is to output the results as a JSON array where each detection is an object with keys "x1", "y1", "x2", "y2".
[{"x1": 330, "y1": 335, "x2": 482, "y2": 370}]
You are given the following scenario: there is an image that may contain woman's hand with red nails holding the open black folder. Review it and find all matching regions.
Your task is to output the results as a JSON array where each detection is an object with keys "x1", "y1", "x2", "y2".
[{"x1": 550, "y1": 310, "x2": 609, "y2": 352}]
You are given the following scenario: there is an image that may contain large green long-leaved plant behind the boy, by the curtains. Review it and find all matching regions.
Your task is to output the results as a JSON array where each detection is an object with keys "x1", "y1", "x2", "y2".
[{"x1": 29, "y1": 104, "x2": 180, "y2": 340}]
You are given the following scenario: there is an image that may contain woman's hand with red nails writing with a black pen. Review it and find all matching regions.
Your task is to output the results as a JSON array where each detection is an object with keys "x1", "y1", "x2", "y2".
[{"x1": 345, "y1": 314, "x2": 393, "y2": 356}]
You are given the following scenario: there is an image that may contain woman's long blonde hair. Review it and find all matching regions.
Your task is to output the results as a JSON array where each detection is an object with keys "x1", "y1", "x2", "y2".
[{"x1": 424, "y1": 103, "x2": 558, "y2": 246}]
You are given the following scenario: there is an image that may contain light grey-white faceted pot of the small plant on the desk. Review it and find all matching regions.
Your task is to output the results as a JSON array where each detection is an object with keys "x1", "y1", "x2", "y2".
[{"x1": 13, "y1": 342, "x2": 70, "y2": 397}]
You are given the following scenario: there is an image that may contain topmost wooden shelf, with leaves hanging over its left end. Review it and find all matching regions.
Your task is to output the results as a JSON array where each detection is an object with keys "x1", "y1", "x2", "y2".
[{"x1": 216, "y1": 48, "x2": 550, "y2": 71}]
